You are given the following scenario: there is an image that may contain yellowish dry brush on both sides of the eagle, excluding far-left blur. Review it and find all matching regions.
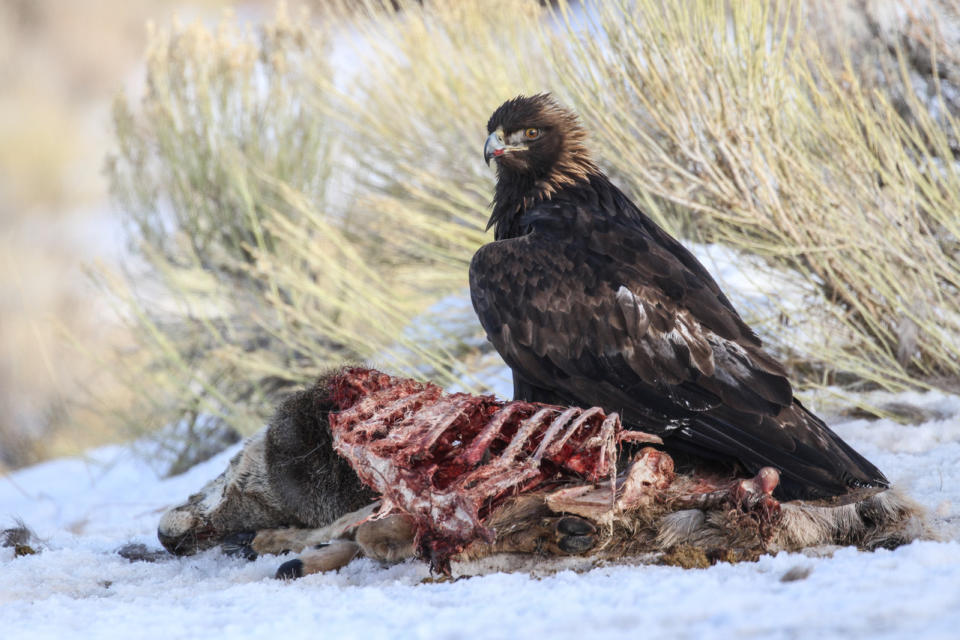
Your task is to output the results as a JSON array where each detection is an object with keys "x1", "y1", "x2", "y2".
[{"x1": 103, "y1": 0, "x2": 960, "y2": 450}]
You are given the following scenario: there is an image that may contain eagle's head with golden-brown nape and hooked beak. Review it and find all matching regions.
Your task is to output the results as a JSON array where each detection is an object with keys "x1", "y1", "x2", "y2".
[{"x1": 483, "y1": 93, "x2": 597, "y2": 198}]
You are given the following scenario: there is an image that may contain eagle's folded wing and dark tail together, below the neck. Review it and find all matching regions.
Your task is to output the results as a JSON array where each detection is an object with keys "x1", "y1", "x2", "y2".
[{"x1": 470, "y1": 210, "x2": 885, "y2": 498}]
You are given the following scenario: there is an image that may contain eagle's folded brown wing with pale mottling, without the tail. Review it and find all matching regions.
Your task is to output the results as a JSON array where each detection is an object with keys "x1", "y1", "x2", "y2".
[{"x1": 470, "y1": 218, "x2": 793, "y2": 415}]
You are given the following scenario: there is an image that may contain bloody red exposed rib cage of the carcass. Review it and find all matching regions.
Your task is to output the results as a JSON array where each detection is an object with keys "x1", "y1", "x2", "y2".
[{"x1": 329, "y1": 368, "x2": 659, "y2": 567}]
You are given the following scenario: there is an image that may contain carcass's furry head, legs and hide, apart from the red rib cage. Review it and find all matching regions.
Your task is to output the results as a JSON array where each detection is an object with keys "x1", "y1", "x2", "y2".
[{"x1": 158, "y1": 368, "x2": 932, "y2": 577}]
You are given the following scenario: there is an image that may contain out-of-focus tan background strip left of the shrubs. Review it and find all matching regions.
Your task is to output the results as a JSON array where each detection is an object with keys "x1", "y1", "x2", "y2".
[{"x1": 0, "y1": 0, "x2": 312, "y2": 472}]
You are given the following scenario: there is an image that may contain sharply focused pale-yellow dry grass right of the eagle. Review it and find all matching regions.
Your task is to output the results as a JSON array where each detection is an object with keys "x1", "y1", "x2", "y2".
[{"x1": 565, "y1": 1, "x2": 960, "y2": 388}]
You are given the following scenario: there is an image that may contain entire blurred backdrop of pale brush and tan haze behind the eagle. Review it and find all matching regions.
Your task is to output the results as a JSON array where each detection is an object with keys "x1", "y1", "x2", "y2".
[{"x1": 0, "y1": 0, "x2": 960, "y2": 470}]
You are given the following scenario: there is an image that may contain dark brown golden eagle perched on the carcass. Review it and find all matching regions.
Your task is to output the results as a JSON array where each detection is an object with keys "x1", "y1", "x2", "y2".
[{"x1": 470, "y1": 94, "x2": 888, "y2": 503}]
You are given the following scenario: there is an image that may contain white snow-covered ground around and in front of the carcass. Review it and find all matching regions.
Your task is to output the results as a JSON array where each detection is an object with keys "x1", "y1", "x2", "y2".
[{"x1": 0, "y1": 393, "x2": 960, "y2": 640}]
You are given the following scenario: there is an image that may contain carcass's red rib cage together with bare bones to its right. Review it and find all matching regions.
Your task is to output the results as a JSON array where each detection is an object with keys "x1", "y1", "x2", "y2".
[{"x1": 329, "y1": 369, "x2": 780, "y2": 571}]
